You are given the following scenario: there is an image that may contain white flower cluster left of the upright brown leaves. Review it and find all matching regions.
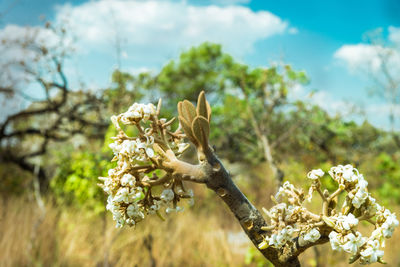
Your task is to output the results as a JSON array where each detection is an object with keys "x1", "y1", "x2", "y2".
[{"x1": 99, "y1": 101, "x2": 193, "y2": 227}]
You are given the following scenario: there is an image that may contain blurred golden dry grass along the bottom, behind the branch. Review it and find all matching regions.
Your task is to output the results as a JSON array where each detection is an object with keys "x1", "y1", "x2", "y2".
[{"x1": 0, "y1": 199, "x2": 400, "y2": 267}]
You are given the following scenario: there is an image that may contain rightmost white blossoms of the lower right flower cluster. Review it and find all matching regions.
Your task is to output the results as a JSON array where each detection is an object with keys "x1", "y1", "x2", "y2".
[{"x1": 328, "y1": 165, "x2": 399, "y2": 264}]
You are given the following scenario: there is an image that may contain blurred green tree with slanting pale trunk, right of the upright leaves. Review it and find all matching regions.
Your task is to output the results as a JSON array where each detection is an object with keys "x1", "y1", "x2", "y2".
[{"x1": 217, "y1": 63, "x2": 308, "y2": 184}]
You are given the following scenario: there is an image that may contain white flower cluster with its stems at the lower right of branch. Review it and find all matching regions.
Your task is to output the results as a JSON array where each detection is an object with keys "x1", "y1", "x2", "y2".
[{"x1": 259, "y1": 165, "x2": 399, "y2": 264}]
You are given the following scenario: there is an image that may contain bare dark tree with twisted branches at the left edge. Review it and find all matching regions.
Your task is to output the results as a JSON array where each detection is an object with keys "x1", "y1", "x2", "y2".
[{"x1": 0, "y1": 24, "x2": 108, "y2": 189}]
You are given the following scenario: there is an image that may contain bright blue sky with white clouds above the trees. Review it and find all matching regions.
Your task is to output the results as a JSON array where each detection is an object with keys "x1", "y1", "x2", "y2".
[{"x1": 0, "y1": 0, "x2": 400, "y2": 130}]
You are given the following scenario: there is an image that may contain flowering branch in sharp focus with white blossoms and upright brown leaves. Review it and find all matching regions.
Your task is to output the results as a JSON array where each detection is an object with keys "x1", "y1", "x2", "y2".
[{"x1": 100, "y1": 92, "x2": 399, "y2": 266}]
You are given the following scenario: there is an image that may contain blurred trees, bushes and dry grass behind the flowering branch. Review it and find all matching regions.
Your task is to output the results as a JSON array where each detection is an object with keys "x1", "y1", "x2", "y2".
[{"x1": 0, "y1": 37, "x2": 400, "y2": 266}]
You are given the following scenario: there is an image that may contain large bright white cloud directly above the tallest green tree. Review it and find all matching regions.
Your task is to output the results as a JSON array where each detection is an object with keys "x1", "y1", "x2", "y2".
[{"x1": 56, "y1": 0, "x2": 288, "y2": 60}]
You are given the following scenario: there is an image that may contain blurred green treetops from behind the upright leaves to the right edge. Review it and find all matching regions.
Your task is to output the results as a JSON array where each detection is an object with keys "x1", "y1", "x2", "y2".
[{"x1": 102, "y1": 43, "x2": 400, "y2": 200}]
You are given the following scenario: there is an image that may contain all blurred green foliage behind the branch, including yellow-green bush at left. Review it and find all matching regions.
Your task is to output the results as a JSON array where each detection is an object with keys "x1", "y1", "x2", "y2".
[{"x1": 0, "y1": 40, "x2": 400, "y2": 220}]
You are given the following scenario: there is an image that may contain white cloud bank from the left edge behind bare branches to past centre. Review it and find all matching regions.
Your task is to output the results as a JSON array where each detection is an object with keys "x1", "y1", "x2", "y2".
[{"x1": 0, "y1": 0, "x2": 288, "y2": 104}]
